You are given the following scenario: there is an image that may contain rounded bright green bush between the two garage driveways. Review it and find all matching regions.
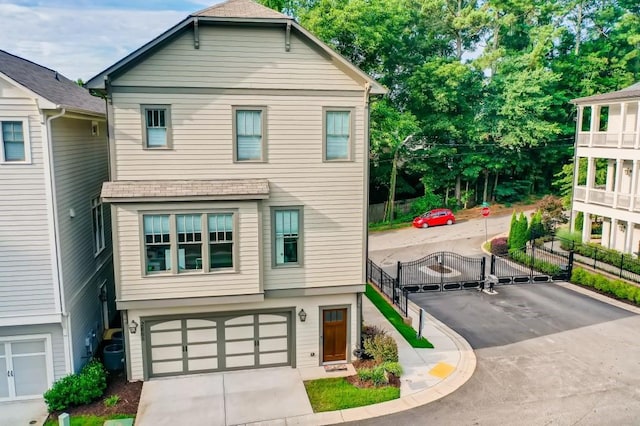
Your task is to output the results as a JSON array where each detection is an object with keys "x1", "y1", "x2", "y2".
[{"x1": 44, "y1": 360, "x2": 107, "y2": 412}]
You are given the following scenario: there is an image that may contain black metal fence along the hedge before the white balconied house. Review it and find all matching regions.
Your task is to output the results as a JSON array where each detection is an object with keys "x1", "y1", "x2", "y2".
[{"x1": 538, "y1": 236, "x2": 640, "y2": 283}]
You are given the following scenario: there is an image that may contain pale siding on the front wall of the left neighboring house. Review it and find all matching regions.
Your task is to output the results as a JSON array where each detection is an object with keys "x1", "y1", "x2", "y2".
[{"x1": 0, "y1": 98, "x2": 55, "y2": 317}]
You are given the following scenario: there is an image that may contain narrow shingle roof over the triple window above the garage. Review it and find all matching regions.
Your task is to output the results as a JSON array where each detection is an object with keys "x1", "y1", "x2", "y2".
[{"x1": 101, "y1": 179, "x2": 269, "y2": 202}]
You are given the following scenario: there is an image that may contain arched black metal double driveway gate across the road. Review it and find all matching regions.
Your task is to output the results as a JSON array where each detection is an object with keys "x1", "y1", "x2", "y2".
[{"x1": 397, "y1": 251, "x2": 486, "y2": 293}]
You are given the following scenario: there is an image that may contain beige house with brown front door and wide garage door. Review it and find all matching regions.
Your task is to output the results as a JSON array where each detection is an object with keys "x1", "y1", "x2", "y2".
[{"x1": 87, "y1": 0, "x2": 385, "y2": 380}]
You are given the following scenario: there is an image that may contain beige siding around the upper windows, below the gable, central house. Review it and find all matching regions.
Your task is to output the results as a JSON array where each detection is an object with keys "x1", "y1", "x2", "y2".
[{"x1": 114, "y1": 94, "x2": 367, "y2": 289}]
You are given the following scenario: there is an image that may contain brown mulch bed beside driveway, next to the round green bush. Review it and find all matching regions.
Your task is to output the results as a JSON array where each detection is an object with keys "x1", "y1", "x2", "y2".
[{"x1": 48, "y1": 372, "x2": 142, "y2": 420}]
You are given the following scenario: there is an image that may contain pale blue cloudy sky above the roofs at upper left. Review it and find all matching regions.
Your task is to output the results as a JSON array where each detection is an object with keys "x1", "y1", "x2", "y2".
[{"x1": 0, "y1": 0, "x2": 222, "y2": 81}]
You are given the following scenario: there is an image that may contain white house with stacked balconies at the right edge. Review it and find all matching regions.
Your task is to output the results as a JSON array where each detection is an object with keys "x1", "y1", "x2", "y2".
[{"x1": 571, "y1": 83, "x2": 640, "y2": 255}]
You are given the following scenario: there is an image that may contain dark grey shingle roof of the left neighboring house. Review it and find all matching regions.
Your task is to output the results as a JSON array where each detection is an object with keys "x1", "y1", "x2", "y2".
[{"x1": 0, "y1": 50, "x2": 105, "y2": 114}]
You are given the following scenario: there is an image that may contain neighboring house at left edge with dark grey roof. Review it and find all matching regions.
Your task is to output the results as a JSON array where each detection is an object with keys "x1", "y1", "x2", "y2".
[{"x1": 0, "y1": 51, "x2": 115, "y2": 402}]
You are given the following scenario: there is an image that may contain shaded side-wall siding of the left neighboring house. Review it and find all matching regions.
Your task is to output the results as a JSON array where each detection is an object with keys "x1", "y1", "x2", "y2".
[{"x1": 51, "y1": 117, "x2": 111, "y2": 307}]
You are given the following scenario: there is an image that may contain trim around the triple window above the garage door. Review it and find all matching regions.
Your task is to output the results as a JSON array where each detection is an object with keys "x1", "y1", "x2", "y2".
[{"x1": 138, "y1": 209, "x2": 240, "y2": 278}]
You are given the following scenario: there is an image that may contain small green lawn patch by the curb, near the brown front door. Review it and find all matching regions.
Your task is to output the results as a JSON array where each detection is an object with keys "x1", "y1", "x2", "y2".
[{"x1": 304, "y1": 377, "x2": 400, "y2": 413}]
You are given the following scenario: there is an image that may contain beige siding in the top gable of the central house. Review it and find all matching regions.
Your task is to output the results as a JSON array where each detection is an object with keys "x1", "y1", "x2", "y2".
[{"x1": 113, "y1": 25, "x2": 362, "y2": 90}]
